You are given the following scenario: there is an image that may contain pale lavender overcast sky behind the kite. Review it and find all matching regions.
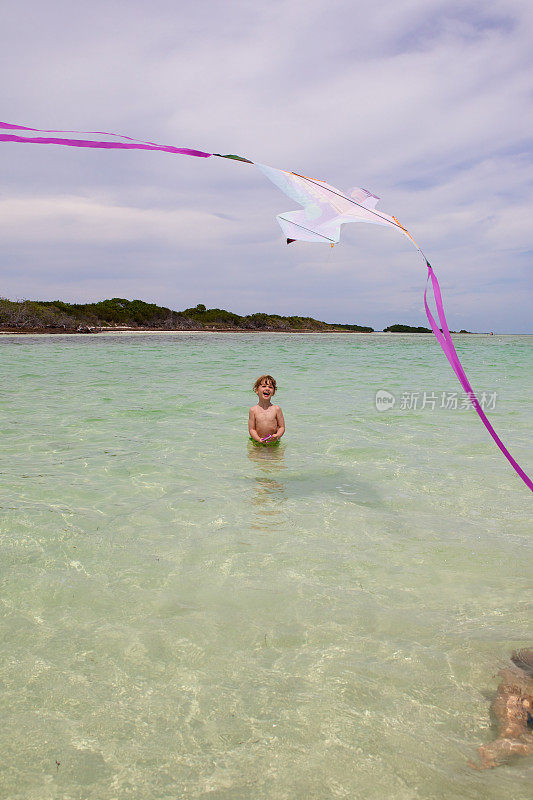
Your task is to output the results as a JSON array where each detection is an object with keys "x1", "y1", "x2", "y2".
[{"x1": 0, "y1": 0, "x2": 533, "y2": 332}]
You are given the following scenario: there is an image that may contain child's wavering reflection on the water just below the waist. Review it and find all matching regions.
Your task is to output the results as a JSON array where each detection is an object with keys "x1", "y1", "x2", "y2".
[{"x1": 248, "y1": 442, "x2": 286, "y2": 510}]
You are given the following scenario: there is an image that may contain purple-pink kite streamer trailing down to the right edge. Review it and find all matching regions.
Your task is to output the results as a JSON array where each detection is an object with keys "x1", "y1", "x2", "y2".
[{"x1": 424, "y1": 259, "x2": 533, "y2": 492}]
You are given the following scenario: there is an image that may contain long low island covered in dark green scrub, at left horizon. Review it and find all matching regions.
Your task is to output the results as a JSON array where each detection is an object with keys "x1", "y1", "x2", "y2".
[{"x1": 0, "y1": 297, "x2": 374, "y2": 333}]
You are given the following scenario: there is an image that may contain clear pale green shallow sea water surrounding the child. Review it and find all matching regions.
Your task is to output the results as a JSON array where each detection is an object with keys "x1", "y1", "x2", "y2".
[{"x1": 0, "y1": 333, "x2": 533, "y2": 800}]
